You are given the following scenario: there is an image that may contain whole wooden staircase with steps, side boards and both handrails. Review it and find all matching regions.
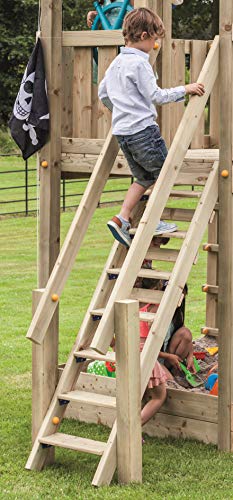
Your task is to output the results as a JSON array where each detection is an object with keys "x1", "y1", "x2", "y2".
[{"x1": 26, "y1": 37, "x2": 218, "y2": 486}]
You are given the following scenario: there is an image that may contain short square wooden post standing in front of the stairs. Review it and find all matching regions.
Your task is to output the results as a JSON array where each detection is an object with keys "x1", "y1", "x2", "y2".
[{"x1": 115, "y1": 300, "x2": 142, "y2": 483}]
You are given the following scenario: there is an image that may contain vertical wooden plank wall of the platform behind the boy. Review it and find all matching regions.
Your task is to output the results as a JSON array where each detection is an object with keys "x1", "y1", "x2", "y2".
[{"x1": 62, "y1": 35, "x2": 219, "y2": 146}]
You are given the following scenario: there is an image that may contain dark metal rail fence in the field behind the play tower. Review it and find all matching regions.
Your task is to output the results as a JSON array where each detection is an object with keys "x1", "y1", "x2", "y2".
[{"x1": 0, "y1": 154, "x2": 130, "y2": 217}]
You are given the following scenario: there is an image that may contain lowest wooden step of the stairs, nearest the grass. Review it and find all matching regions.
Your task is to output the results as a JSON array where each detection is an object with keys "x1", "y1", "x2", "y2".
[{"x1": 39, "y1": 432, "x2": 106, "y2": 455}]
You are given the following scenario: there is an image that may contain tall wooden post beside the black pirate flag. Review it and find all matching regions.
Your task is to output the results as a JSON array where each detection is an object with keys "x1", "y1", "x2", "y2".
[{"x1": 32, "y1": 0, "x2": 62, "y2": 454}]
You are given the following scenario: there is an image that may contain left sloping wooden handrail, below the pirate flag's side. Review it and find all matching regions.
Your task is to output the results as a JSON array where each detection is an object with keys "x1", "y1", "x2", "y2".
[{"x1": 26, "y1": 130, "x2": 119, "y2": 344}]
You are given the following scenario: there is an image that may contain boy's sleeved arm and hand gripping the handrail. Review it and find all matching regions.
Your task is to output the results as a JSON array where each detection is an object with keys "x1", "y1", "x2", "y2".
[{"x1": 137, "y1": 64, "x2": 205, "y2": 105}]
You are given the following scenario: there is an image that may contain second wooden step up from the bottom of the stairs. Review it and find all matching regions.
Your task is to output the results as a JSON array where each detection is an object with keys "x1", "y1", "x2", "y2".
[{"x1": 58, "y1": 390, "x2": 116, "y2": 408}]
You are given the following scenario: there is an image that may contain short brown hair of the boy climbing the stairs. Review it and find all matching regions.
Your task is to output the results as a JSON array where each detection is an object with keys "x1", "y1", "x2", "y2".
[{"x1": 123, "y1": 7, "x2": 165, "y2": 43}]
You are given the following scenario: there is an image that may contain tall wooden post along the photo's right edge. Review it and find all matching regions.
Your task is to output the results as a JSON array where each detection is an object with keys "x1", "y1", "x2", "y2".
[{"x1": 218, "y1": 0, "x2": 233, "y2": 451}]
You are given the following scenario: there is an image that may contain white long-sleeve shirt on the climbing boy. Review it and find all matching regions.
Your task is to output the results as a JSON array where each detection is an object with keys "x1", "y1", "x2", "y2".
[{"x1": 98, "y1": 47, "x2": 185, "y2": 135}]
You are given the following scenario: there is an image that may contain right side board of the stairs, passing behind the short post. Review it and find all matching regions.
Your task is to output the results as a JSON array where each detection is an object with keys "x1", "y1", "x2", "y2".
[{"x1": 92, "y1": 162, "x2": 218, "y2": 486}]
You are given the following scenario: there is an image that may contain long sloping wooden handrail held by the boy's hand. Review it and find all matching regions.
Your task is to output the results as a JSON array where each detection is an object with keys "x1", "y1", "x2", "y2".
[{"x1": 91, "y1": 37, "x2": 219, "y2": 354}]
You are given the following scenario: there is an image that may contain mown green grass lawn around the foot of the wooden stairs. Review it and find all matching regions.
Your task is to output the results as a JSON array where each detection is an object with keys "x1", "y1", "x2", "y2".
[{"x1": 0, "y1": 193, "x2": 233, "y2": 500}]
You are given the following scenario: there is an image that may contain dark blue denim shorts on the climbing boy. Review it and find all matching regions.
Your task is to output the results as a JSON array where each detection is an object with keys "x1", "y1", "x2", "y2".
[{"x1": 116, "y1": 125, "x2": 167, "y2": 188}]
